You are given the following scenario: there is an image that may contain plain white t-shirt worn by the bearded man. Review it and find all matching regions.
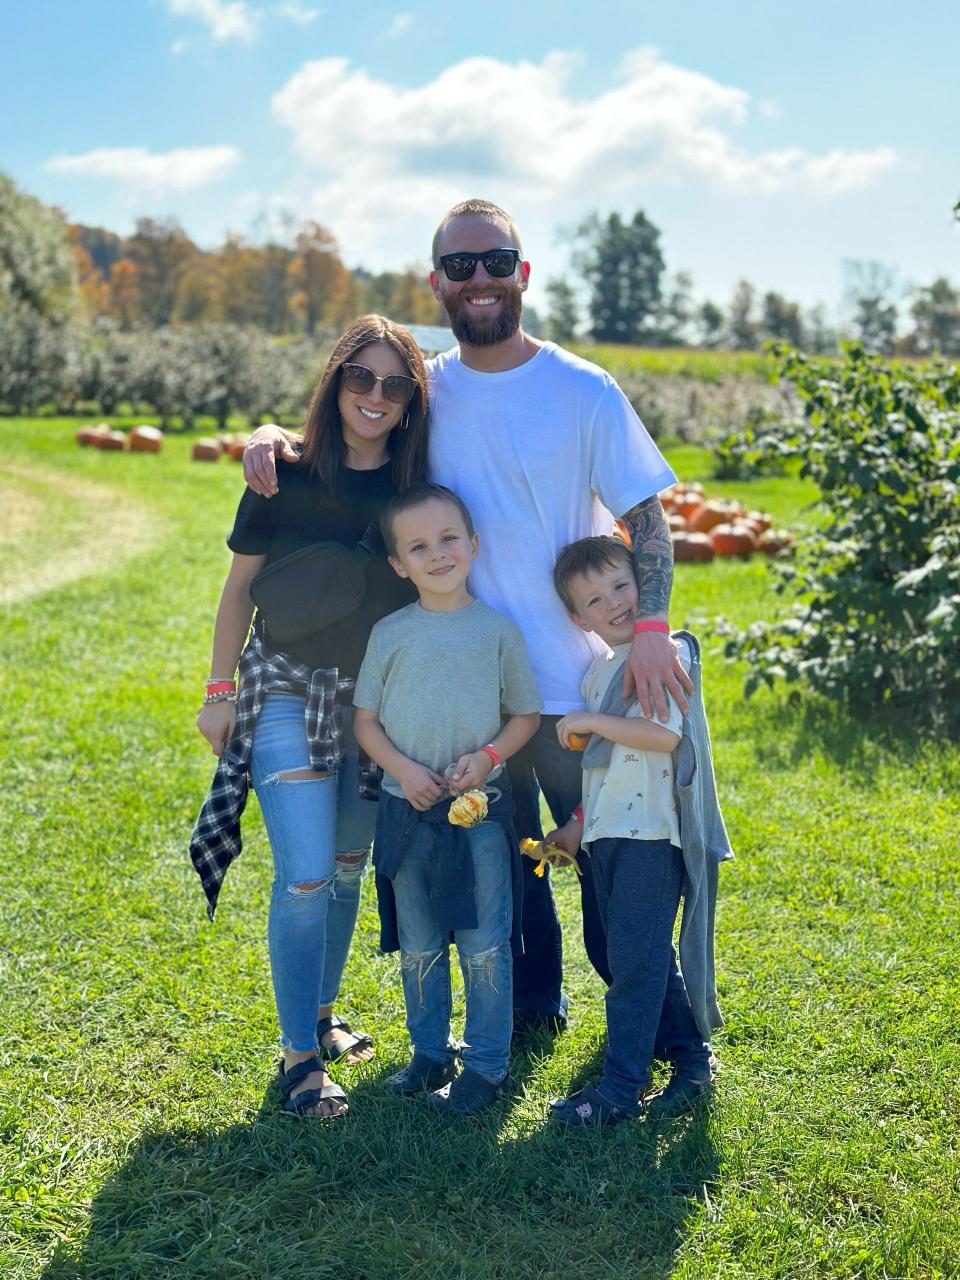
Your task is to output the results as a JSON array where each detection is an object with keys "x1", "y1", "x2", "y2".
[{"x1": 428, "y1": 342, "x2": 676, "y2": 716}]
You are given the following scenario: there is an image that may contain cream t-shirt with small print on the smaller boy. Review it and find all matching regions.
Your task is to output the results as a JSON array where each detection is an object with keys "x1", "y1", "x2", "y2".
[{"x1": 582, "y1": 641, "x2": 690, "y2": 847}]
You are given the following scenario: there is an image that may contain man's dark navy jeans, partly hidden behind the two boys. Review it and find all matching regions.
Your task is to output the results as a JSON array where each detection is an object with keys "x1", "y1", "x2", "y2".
[{"x1": 507, "y1": 716, "x2": 611, "y2": 1014}]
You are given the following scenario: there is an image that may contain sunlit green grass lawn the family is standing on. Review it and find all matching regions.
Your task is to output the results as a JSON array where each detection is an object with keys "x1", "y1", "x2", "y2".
[{"x1": 0, "y1": 420, "x2": 960, "y2": 1280}]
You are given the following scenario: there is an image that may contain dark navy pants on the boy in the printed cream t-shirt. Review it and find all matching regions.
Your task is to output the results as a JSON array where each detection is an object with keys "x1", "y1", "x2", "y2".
[{"x1": 589, "y1": 840, "x2": 710, "y2": 1107}]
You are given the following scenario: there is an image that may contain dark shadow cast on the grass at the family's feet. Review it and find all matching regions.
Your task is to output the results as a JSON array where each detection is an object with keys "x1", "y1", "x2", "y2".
[{"x1": 44, "y1": 1064, "x2": 717, "y2": 1280}]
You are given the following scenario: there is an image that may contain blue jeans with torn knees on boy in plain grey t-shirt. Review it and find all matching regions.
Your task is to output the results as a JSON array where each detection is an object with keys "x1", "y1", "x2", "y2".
[{"x1": 393, "y1": 822, "x2": 513, "y2": 1082}]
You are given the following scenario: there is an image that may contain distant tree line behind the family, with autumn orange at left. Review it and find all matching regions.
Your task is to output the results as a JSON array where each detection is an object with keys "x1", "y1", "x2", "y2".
[{"x1": 0, "y1": 174, "x2": 960, "y2": 424}]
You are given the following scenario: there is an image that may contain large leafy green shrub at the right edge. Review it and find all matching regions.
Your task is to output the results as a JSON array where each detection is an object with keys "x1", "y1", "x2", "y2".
[{"x1": 717, "y1": 347, "x2": 960, "y2": 733}]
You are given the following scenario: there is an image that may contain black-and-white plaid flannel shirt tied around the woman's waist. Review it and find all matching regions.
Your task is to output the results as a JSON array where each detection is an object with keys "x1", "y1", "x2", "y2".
[{"x1": 189, "y1": 618, "x2": 380, "y2": 920}]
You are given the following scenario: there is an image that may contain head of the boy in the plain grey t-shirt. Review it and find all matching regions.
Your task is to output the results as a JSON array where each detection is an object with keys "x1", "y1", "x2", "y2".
[{"x1": 390, "y1": 498, "x2": 477, "y2": 613}]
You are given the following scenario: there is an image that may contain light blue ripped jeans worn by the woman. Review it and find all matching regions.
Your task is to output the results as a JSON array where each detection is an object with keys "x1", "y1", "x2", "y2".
[{"x1": 250, "y1": 694, "x2": 376, "y2": 1051}]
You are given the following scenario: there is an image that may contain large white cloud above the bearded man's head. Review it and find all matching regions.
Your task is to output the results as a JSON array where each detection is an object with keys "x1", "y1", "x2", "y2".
[{"x1": 271, "y1": 49, "x2": 896, "y2": 270}]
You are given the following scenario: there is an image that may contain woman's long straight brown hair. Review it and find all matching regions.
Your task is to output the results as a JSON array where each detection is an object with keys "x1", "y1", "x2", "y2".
[{"x1": 303, "y1": 315, "x2": 428, "y2": 490}]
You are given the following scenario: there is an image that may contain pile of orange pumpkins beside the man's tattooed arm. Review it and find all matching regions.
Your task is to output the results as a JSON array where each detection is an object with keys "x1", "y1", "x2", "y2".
[{"x1": 660, "y1": 484, "x2": 794, "y2": 562}]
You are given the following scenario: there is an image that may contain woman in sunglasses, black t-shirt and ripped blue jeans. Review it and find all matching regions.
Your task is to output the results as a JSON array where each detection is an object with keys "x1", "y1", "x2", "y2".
[{"x1": 191, "y1": 315, "x2": 428, "y2": 1117}]
